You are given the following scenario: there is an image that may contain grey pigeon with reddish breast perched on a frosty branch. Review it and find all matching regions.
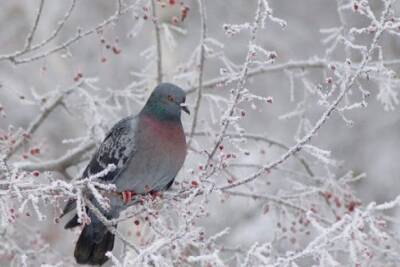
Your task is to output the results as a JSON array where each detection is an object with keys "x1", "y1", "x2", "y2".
[{"x1": 62, "y1": 83, "x2": 189, "y2": 265}]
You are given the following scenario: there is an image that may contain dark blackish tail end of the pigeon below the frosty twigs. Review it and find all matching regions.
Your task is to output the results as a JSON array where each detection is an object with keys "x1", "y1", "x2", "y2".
[{"x1": 74, "y1": 222, "x2": 114, "y2": 265}]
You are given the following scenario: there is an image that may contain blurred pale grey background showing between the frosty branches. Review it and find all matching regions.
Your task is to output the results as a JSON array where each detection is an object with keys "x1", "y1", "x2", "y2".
[{"x1": 0, "y1": 0, "x2": 400, "y2": 266}]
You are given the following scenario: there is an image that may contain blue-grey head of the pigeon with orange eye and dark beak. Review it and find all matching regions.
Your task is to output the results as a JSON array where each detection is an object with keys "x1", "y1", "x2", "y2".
[{"x1": 143, "y1": 83, "x2": 190, "y2": 120}]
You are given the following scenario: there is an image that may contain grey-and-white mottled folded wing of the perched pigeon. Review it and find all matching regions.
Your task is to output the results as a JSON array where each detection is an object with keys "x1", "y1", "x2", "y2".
[{"x1": 82, "y1": 117, "x2": 137, "y2": 182}]
